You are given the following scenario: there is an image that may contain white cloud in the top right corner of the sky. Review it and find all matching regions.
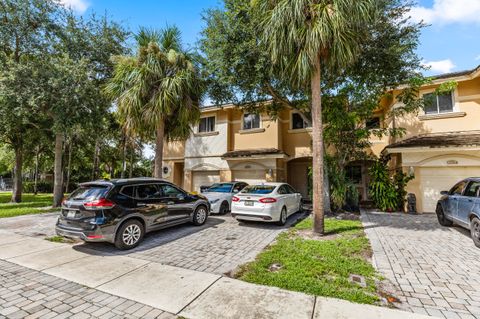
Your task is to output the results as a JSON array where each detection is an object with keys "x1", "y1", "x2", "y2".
[{"x1": 410, "y1": 0, "x2": 480, "y2": 24}]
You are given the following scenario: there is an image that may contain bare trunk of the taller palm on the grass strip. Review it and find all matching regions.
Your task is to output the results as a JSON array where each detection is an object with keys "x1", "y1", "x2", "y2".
[{"x1": 310, "y1": 57, "x2": 324, "y2": 235}]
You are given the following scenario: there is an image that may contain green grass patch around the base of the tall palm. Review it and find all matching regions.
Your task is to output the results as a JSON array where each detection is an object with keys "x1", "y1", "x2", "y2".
[{"x1": 237, "y1": 218, "x2": 379, "y2": 304}]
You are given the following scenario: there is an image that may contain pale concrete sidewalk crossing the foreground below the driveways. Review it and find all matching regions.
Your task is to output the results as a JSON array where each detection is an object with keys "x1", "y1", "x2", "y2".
[{"x1": 0, "y1": 231, "x2": 436, "y2": 319}]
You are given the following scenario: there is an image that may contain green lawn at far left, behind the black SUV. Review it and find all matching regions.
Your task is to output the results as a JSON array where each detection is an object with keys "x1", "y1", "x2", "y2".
[{"x1": 0, "y1": 193, "x2": 59, "y2": 218}]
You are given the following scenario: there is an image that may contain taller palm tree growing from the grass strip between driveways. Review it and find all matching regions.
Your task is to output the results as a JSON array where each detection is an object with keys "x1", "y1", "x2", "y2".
[{"x1": 252, "y1": 0, "x2": 379, "y2": 234}]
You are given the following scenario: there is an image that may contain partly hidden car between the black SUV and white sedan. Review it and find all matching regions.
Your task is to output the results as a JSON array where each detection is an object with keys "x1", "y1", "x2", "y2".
[{"x1": 202, "y1": 182, "x2": 248, "y2": 214}]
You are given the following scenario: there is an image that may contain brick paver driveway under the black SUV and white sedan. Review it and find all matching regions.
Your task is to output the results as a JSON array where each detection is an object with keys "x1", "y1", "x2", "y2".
[{"x1": 0, "y1": 213, "x2": 304, "y2": 274}]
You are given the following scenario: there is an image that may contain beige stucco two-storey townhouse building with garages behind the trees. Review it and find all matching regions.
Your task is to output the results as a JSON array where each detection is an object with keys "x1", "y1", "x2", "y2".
[{"x1": 163, "y1": 67, "x2": 480, "y2": 212}]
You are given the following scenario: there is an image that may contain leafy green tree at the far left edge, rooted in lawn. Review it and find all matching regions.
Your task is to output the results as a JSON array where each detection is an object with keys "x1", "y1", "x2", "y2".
[{"x1": 0, "y1": 0, "x2": 58, "y2": 202}]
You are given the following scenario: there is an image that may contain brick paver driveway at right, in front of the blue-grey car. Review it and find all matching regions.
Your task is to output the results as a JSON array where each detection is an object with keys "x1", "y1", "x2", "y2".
[{"x1": 362, "y1": 212, "x2": 480, "y2": 318}]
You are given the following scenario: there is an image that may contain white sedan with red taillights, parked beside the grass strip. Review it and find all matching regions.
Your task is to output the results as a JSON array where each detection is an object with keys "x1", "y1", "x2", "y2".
[{"x1": 232, "y1": 183, "x2": 302, "y2": 225}]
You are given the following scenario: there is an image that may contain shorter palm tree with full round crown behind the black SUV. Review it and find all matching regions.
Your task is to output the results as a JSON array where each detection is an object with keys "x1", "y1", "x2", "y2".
[{"x1": 105, "y1": 27, "x2": 203, "y2": 178}]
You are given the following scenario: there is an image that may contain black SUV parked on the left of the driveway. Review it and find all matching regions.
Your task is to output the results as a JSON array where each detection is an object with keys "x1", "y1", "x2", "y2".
[{"x1": 56, "y1": 178, "x2": 210, "y2": 249}]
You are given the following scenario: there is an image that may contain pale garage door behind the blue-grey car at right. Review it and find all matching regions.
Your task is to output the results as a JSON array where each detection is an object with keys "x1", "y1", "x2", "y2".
[{"x1": 418, "y1": 167, "x2": 480, "y2": 213}]
